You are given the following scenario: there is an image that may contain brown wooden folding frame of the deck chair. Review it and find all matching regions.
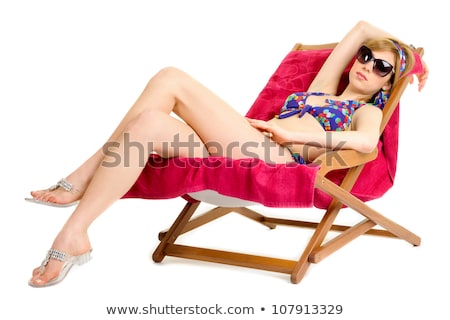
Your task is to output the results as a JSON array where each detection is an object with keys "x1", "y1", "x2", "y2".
[{"x1": 152, "y1": 44, "x2": 423, "y2": 283}]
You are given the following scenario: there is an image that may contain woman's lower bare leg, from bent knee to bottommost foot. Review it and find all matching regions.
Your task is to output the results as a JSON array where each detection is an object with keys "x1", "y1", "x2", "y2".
[{"x1": 31, "y1": 111, "x2": 206, "y2": 285}]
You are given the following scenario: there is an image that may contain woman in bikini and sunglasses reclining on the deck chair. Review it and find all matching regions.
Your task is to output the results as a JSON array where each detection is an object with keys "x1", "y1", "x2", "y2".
[{"x1": 29, "y1": 22, "x2": 428, "y2": 287}]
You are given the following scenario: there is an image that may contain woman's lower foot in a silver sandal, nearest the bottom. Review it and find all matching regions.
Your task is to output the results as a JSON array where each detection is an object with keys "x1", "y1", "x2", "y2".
[{"x1": 28, "y1": 233, "x2": 92, "y2": 287}]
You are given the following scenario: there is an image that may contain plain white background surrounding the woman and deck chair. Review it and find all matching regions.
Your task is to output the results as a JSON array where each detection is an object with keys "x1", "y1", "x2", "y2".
[{"x1": 0, "y1": 0, "x2": 450, "y2": 319}]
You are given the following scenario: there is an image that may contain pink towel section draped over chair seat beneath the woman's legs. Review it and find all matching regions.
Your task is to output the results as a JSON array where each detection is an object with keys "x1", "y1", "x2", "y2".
[{"x1": 124, "y1": 155, "x2": 318, "y2": 207}]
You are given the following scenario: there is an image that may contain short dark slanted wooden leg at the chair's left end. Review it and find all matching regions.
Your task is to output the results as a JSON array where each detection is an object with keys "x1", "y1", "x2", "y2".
[{"x1": 152, "y1": 202, "x2": 200, "y2": 262}]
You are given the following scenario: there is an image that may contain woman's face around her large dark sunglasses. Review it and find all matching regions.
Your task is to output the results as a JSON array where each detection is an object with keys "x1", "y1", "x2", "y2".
[{"x1": 349, "y1": 47, "x2": 395, "y2": 96}]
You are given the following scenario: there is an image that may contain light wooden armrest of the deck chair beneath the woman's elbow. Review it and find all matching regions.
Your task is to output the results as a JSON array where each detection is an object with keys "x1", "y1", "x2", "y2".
[{"x1": 312, "y1": 148, "x2": 378, "y2": 176}]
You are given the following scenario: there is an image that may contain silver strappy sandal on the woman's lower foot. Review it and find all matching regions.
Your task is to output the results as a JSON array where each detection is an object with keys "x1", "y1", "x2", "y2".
[{"x1": 28, "y1": 249, "x2": 92, "y2": 288}]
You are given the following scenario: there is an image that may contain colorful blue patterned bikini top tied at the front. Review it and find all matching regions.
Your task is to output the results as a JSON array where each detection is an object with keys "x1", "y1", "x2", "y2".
[{"x1": 278, "y1": 92, "x2": 378, "y2": 131}]
